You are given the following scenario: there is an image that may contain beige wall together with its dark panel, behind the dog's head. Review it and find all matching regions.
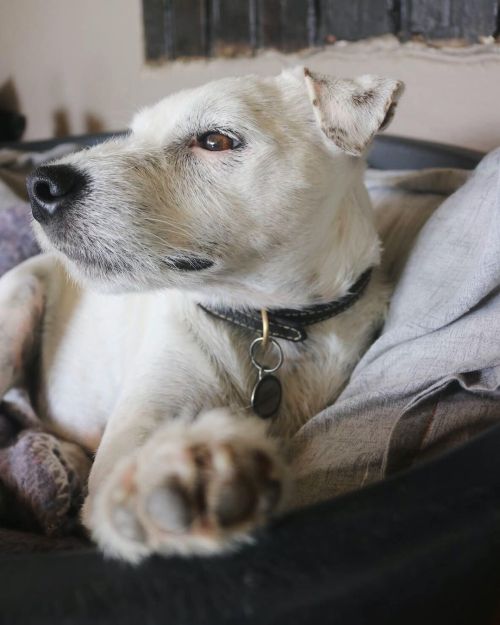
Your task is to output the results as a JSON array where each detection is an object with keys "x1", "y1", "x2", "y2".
[{"x1": 0, "y1": 0, "x2": 500, "y2": 150}]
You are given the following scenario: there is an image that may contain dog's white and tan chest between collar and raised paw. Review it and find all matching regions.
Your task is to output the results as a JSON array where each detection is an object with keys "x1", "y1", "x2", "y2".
[{"x1": 37, "y1": 280, "x2": 385, "y2": 449}]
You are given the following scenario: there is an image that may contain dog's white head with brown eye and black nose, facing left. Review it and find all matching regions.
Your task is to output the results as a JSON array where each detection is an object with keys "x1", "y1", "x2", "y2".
[{"x1": 28, "y1": 68, "x2": 402, "y2": 305}]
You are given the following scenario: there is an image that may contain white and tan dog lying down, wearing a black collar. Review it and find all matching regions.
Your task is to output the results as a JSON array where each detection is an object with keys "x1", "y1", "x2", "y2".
[{"x1": 0, "y1": 68, "x2": 403, "y2": 563}]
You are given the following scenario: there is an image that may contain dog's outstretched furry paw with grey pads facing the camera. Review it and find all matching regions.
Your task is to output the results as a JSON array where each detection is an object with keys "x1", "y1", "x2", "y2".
[{"x1": 84, "y1": 410, "x2": 285, "y2": 561}]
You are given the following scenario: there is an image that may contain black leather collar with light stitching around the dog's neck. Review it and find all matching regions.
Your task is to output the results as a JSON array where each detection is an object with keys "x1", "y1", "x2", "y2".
[{"x1": 198, "y1": 267, "x2": 373, "y2": 342}]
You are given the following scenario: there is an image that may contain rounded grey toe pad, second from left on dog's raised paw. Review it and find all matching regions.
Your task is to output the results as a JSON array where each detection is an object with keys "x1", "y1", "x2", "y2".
[{"x1": 146, "y1": 486, "x2": 193, "y2": 533}]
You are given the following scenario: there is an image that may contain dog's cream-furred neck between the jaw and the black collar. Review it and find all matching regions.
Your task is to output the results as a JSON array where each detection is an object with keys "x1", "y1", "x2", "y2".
[{"x1": 198, "y1": 167, "x2": 380, "y2": 309}]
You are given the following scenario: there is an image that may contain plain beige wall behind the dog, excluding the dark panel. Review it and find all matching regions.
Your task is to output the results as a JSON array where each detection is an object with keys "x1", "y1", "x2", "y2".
[{"x1": 0, "y1": 0, "x2": 500, "y2": 150}]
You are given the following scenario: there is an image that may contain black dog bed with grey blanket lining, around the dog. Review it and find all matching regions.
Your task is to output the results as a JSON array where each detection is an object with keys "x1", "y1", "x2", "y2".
[{"x1": 0, "y1": 137, "x2": 500, "y2": 625}]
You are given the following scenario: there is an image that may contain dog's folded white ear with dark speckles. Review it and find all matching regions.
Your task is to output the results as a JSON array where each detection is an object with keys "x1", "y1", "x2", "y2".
[{"x1": 304, "y1": 68, "x2": 404, "y2": 156}]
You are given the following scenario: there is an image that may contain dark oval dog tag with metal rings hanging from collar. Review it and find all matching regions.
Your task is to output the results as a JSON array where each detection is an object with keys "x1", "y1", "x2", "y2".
[{"x1": 250, "y1": 337, "x2": 283, "y2": 419}]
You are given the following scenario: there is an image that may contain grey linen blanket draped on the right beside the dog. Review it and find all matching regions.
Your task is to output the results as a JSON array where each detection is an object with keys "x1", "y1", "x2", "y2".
[{"x1": 292, "y1": 150, "x2": 500, "y2": 504}]
